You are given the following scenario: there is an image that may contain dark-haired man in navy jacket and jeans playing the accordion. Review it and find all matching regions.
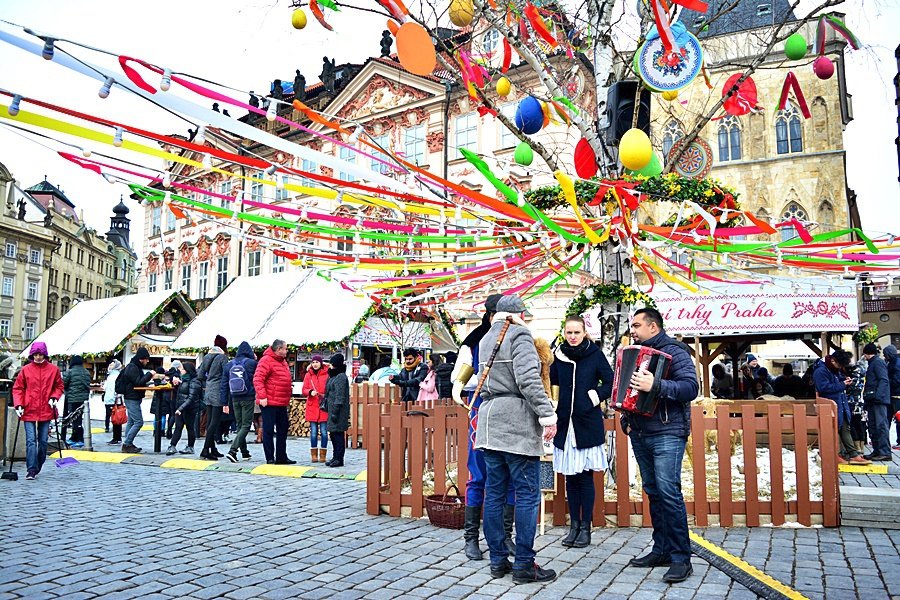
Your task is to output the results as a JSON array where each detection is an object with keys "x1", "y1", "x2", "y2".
[{"x1": 622, "y1": 308, "x2": 699, "y2": 583}]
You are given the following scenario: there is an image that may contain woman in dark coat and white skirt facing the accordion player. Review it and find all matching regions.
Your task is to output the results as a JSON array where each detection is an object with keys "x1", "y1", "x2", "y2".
[{"x1": 550, "y1": 316, "x2": 613, "y2": 548}]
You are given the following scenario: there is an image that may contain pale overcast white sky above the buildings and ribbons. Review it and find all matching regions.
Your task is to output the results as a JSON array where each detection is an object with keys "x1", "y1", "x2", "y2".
[{"x1": 0, "y1": 0, "x2": 900, "y2": 252}]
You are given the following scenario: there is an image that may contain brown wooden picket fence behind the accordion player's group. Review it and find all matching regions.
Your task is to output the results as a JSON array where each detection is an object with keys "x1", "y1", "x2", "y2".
[{"x1": 364, "y1": 400, "x2": 839, "y2": 527}]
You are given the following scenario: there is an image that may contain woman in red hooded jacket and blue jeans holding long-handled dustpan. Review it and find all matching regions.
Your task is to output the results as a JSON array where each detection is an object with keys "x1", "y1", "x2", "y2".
[{"x1": 12, "y1": 342, "x2": 65, "y2": 481}]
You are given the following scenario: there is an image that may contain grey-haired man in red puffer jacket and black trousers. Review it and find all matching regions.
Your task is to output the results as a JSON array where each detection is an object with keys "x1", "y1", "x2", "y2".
[{"x1": 253, "y1": 340, "x2": 297, "y2": 465}]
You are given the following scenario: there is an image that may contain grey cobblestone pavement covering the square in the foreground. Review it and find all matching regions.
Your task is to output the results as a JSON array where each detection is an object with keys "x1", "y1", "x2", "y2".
[{"x1": 0, "y1": 460, "x2": 900, "y2": 600}]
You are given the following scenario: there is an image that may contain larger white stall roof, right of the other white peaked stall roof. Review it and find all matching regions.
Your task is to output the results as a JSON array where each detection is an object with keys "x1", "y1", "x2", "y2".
[{"x1": 172, "y1": 269, "x2": 372, "y2": 350}]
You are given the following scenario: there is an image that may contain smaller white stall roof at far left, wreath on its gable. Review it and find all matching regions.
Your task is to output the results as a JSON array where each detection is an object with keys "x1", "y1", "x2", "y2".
[{"x1": 19, "y1": 290, "x2": 194, "y2": 358}]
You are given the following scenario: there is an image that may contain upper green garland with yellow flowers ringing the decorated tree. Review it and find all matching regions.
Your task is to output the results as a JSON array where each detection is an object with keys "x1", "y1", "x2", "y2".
[{"x1": 525, "y1": 173, "x2": 741, "y2": 226}]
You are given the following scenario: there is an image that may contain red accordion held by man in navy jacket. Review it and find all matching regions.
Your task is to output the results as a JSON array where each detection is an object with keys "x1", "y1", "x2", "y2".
[{"x1": 610, "y1": 346, "x2": 672, "y2": 417}]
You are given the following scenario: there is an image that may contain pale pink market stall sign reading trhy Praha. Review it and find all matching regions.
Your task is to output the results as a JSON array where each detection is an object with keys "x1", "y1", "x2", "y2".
[{"x1": 650, "y1": 279, "x2": 859, "y2": 336}]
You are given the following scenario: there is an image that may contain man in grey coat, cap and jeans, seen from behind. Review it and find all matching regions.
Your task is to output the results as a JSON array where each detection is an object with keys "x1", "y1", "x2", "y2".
[{"x1": 475, "y1": 296, "x2": 557, "y2": 584}]
